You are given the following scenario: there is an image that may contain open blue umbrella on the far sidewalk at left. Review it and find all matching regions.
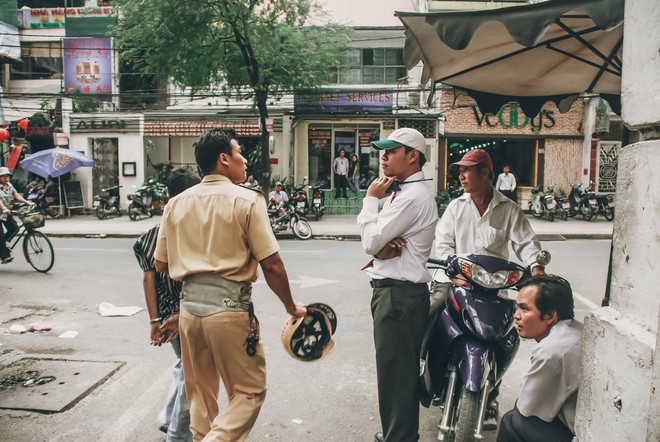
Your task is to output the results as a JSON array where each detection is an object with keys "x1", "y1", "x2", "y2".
[{"x1": 18, "y1": 147, "x2": 94, "y2": 178}]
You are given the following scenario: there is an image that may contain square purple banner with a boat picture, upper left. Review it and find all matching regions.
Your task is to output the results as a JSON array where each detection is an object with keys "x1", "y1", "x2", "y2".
[{"x1": 63, "y1": 37, "x2": 113, "y2": 95}]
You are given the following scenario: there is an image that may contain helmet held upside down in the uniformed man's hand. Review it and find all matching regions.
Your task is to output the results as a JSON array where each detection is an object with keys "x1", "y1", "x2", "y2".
[{"x1": 282, "y1": 303, "x2": 337, "y2": 362}]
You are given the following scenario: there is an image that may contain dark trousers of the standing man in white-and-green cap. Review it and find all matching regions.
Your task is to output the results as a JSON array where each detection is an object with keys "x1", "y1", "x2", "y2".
[{"x1": 371, "y1": 281, "x2": 429, "y2": 442}]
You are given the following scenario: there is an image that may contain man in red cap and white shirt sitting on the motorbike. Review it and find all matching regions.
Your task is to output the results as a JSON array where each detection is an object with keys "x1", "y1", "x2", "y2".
[{"x1": 430, "y1": 149, "x2": 545, "y2": 430}]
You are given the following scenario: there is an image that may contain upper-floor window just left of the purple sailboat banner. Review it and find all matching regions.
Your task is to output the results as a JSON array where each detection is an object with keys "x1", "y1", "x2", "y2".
[{"x1": 9, "y1": 41, "x2": 63, "y2": 80}]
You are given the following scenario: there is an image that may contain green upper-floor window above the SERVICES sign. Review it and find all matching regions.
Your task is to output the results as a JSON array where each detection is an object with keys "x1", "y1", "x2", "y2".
[{"x1": 337, "y1": 48, "x2": 408, "y2": 84}]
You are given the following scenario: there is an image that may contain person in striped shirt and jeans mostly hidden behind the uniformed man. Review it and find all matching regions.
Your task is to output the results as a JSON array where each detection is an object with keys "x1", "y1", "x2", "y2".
[{"x1": 133, "y1": 168, "x2": 200, "y2": 442}]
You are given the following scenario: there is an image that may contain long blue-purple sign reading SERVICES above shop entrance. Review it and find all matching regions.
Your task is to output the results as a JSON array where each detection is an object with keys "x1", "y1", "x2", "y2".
[{"x1": 293, "y1": 91, "x2": 392, "y2": 113}]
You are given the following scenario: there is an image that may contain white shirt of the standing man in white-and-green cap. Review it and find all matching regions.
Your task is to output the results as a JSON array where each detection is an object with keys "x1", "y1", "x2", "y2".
[{"x1": 357, "y1": 172, "x2": 438, "y2": 283}]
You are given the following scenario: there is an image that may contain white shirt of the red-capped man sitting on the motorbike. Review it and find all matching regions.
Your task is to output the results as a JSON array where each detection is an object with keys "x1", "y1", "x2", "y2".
[{"x1": 435, "y1": 189, "x2": 541, "y2": 282}]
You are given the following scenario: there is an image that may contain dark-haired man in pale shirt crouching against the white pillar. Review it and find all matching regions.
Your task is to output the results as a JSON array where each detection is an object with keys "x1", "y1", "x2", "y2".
[{"x1": 497, "y1": 275, "x2": 582, "y2": 442}]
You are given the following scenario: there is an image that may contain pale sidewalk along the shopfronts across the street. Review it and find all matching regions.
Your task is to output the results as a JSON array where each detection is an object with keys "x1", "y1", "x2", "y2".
[{"x1": 40, "y1": 214, "x2": 613, "y2": 241}]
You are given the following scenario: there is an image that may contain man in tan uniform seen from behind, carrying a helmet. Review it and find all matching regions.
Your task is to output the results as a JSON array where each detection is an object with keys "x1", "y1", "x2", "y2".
[{"x1": 154, "y1": 130, "x2": 306, "y2": 441}]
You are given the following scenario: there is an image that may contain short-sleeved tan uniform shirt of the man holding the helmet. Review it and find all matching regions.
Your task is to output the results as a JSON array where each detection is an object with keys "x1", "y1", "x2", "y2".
[{"x1": 154, "y1": 175, "x2": 279, "y2": 282}]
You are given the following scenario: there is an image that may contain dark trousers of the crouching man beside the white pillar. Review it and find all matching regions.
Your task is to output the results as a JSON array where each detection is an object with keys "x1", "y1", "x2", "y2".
[{"x1": 497, "y1": 407, "x2": 573, "y2": 442}]
